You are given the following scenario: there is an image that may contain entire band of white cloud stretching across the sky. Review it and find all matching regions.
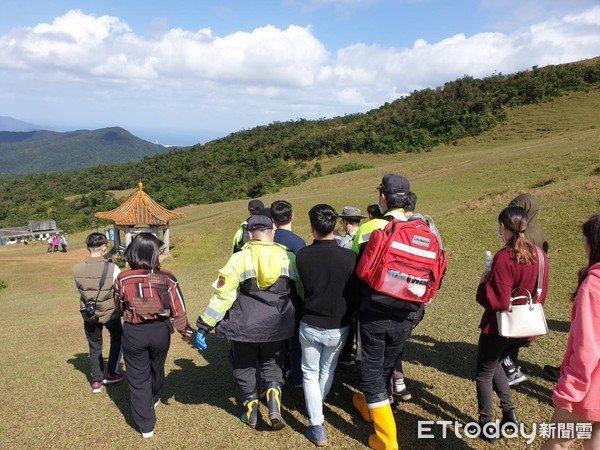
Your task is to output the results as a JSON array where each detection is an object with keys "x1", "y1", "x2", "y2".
[{"x1": 0, "y1": 5, "x2": 600, "y2": 141}]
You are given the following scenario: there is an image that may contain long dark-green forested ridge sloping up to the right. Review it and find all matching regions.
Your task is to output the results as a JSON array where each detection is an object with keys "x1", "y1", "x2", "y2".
[{"x1": 0, "y1": 58, "x2": 600, "y2": 231}]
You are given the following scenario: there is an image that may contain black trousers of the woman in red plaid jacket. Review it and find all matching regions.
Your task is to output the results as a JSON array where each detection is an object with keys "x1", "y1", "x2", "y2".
[{"x1": 123, "y1": 321, "x2": 171, "y2": 433}]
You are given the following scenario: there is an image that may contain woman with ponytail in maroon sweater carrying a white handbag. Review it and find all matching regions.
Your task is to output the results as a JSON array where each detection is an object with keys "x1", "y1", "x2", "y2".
[{"x1": 475, "y1": 206, "x2": 548, "y2": 440}]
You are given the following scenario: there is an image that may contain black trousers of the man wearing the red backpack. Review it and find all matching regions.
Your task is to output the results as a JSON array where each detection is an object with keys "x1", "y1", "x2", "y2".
[{"x1": 360, "y1": 309, "x2": 413, "y2": 404}]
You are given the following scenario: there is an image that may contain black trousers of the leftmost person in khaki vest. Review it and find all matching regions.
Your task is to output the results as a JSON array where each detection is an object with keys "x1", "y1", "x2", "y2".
[{"x1": 83, "y1": 317, "x2": 123, "y2": 383}]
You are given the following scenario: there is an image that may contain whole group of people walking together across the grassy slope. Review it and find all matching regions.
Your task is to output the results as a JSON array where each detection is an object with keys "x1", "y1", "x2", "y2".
[{"x1": 74, "y1": 174, "x2": 600, "y2": 449}]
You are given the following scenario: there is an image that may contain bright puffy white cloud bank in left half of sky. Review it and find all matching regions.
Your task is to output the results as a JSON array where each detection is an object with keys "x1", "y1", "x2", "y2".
[{"x1": 0, "y1": 10, "x2": 328, "y2": 87}]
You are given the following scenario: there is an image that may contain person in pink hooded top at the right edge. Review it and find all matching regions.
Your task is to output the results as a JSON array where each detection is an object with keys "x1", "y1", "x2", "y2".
[{"x1": 542, "y1": 212, "x2": 600, "y2": 450}]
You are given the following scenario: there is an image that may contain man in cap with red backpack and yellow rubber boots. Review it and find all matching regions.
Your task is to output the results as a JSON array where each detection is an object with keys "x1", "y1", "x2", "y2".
[{"x1": 352, "y1": 174, "x2": 446, "y2": 449}]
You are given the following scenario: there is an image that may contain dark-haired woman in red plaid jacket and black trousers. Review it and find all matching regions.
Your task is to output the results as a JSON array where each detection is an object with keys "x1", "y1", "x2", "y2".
[{"x1": 115, "y1": 233, "x2": 193, "y2": 438}]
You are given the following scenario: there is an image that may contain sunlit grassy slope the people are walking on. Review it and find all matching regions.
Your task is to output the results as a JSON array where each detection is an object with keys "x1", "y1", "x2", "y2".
[{"x1": 0, "y1": 92, "x2": 600, "y2": 449}]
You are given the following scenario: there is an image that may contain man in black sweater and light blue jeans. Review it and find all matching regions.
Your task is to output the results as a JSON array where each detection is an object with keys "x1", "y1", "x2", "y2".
[{"x1": 296, "y1": 205, "x2": 357, "y2": 446}]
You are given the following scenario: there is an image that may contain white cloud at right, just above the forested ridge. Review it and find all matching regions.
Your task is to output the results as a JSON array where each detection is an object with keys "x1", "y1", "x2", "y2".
[{"x1": 322, "y1": 6, "x2": 600, "y2": 104}]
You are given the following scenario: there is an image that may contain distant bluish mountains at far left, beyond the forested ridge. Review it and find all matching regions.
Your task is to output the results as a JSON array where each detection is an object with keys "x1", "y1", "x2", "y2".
[{"x1": 0, "y1": 116, "x2": 169, "y2": 175}]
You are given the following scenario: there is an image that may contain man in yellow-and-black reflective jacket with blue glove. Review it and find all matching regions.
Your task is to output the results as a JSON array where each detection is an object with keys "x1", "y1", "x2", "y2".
[{"x1": 196, "y1": 215, "x2": 300, "y2": 430}]
